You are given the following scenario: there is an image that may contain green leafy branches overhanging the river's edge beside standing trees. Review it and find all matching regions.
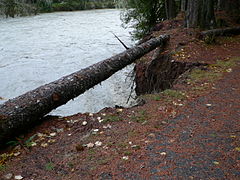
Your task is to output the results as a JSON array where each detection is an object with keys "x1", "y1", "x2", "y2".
[{"x1": 121, "y1": 0, "x2": 166, "y2": 39}]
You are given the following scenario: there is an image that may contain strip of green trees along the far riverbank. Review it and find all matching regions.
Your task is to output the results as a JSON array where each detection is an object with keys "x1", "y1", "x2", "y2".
[{"x1": 0, "y1": 0, "x2": 115, "y2": 17}]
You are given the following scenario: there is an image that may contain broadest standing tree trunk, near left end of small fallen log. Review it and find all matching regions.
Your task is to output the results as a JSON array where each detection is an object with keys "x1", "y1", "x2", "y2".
[{"x1": 185, "y1": 0, "x2": 215, "y2": 29}]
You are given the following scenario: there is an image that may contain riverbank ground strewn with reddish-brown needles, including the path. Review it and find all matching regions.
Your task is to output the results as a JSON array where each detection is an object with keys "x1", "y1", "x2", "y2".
[{"x1": 0, "y1": 20, "x2": 240, "y2": 180}]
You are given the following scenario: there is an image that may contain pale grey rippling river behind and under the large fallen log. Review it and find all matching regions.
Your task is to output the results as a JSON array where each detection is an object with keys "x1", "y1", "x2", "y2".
[{"x1": 0, "y1": 9, "x2": 136, "y2": 116}]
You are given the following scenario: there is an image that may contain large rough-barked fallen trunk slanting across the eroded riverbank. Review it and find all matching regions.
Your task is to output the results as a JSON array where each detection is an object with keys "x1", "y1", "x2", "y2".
[{"x1": 0, "y1": 35, "x2": 170, "y2": 145}]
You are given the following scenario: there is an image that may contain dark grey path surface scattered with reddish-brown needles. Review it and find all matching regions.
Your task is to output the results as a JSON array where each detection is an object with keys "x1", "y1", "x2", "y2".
[{"x1": 101, "y1": 62, "x2": 240, "y2": 180}]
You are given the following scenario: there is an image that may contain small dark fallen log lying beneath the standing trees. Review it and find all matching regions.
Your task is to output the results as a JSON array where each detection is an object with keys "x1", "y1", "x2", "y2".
[{"x1": 199, "y1": 27, "x2": 240, "y2": 40}]
